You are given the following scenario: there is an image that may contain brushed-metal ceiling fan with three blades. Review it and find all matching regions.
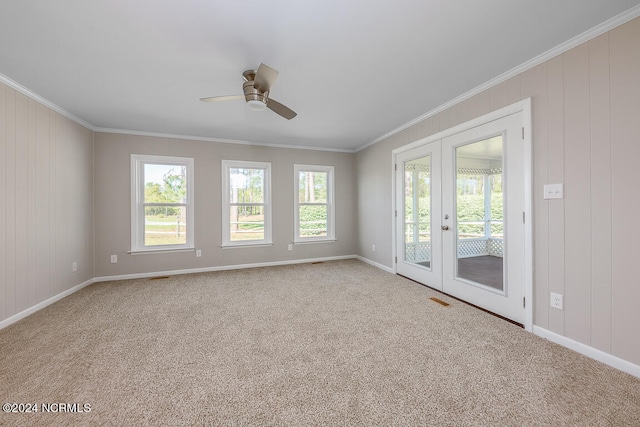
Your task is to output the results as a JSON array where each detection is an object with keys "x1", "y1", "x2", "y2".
[{"x1": 200, "y1": 64, "x2": 297, "y2": 120}]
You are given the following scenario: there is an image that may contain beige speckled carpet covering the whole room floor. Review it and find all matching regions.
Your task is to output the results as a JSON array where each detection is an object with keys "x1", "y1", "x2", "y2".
[{"x1": 0, "y1": 260, "x2": 640, "y2": 426}]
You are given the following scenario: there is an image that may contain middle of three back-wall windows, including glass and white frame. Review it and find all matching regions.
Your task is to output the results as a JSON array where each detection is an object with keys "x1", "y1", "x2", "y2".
[{"x1": 222, "y1": 160, "x2": 271, "y2": 246}]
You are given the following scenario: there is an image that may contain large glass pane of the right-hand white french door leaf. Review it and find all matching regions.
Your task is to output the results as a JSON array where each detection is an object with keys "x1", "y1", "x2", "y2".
[{"x1": 456, "y1": 135, "x2": 504, "y2": 291}]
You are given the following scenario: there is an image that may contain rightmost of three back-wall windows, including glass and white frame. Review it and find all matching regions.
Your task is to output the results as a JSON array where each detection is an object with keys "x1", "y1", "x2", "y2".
[{"x1": 294, "y1": 165, "x2": 335, "y2": 243}]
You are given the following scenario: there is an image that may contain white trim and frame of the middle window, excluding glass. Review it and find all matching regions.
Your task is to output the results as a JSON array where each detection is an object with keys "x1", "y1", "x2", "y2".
[{"x1": 221, "y1": 160, "x2": 273, "y2": 248}]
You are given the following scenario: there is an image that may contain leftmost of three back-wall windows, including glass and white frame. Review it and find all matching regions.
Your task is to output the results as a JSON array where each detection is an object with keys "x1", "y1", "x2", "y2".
[{"x1": 131, "y1": 154, "x2": 194, "y2": 252}]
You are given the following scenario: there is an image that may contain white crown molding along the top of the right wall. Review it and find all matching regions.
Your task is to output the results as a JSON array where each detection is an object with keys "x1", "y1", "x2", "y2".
[{"x1": 354, "y1": 5, "x2": 640, "y2": 152}]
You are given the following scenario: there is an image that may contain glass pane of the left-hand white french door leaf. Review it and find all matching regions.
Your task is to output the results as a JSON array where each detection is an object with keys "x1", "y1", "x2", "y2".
[{"x1": 404, "y1": 156, "x2": 431, "y2": 269}]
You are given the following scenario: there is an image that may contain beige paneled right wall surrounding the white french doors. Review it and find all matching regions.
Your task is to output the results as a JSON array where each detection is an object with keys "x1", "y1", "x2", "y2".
[{"x1": 356, "y1": 18, "x2": 640, "y2": 364}]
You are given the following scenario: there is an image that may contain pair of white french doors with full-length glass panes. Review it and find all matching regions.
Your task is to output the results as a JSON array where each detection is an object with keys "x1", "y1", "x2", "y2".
[{"x1": 395, "y1": 112, "x2": 527, "y2": 323}]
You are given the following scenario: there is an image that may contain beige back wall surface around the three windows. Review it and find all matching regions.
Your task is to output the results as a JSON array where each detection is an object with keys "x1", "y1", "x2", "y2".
[{"x1": 95, "y1": 133, "x2": 356, "y2": 277}]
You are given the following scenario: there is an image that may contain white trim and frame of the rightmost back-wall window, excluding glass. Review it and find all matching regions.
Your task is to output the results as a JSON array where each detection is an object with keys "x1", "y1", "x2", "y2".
[{"x1": 293, "y1": 164, "x2": 336, "y2": 244}]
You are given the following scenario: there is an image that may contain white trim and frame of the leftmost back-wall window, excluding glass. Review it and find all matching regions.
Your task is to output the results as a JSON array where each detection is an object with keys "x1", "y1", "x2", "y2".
[{"x1": 129, "y1": 154, "x2": 195, "y2": 254}]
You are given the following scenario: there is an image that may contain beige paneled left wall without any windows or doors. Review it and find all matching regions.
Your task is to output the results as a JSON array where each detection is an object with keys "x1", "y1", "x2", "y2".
[{"x1": 0, "y1": 83, "x2": 94, "y2": 321}]
